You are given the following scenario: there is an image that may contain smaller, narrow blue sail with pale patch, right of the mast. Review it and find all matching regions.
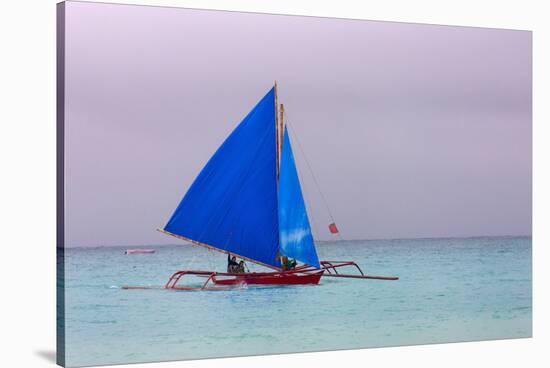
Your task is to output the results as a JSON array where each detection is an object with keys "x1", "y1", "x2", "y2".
[{"x1": 279, "y1": 127, "x2": 320, "y2": 268}]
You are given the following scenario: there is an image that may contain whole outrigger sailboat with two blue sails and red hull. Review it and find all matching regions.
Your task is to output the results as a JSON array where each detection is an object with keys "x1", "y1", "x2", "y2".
[{"x1": 123, "y1": 82, "x2": 398, "y2": 290}]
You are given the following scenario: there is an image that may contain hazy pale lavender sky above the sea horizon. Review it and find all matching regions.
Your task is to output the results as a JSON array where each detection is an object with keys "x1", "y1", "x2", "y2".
[{"x1": 65, "y1": 2, "x2": 532, "y2": 247}]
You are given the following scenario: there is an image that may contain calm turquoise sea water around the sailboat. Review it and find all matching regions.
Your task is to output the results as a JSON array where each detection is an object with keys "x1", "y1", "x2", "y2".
[{"x1": 65, "y1": 237, "x2": 532, "y2": 366}]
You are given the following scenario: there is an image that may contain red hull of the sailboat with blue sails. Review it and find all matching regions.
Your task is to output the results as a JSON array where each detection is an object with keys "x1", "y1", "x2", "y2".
[{"x1": 212, "y1": 271, "x2": 324, "y2": 285}]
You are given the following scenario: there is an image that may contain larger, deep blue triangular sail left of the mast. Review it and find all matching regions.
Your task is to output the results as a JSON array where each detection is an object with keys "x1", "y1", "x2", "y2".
[{"x1": 164, "y1": 88, "x2": 281, "y2": 268}]
